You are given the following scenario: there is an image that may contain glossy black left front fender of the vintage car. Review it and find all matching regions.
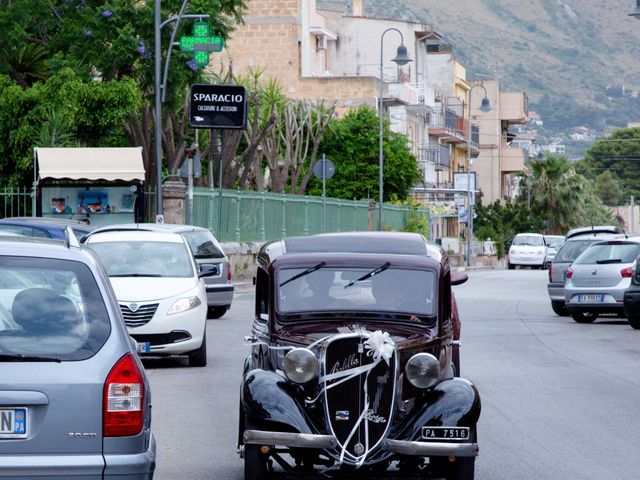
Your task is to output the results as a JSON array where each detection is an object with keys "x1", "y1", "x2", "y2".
[{"x1": 240, "y1": 369, "x2": 312, "y2": 433}]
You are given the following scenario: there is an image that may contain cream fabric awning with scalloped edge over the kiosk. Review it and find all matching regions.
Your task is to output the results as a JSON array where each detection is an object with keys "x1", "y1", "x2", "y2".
[{"x1": 34, "y1": 147, "x2": 144, "y2": 181}]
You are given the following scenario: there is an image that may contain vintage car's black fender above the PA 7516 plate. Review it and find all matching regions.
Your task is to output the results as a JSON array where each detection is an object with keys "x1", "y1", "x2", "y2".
[{"x1": 396, "y1": 378, "x2": 480, "y2": 440}]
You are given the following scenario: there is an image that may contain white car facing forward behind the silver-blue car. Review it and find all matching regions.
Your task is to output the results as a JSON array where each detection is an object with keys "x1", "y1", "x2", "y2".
[{"x1": 84, "y1": 227, "x2": 207, "y2": 367}]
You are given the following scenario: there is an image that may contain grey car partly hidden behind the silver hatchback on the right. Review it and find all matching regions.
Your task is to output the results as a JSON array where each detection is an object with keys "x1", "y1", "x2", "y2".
[{"x1": 547, "y1": 230, "x2": 624, "y2": 317}]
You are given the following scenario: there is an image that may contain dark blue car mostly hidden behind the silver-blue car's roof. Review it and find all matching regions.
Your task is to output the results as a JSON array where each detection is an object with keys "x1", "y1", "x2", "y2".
[{"x1": 0, "y1": 217, "x2": 94, "y2": 240}]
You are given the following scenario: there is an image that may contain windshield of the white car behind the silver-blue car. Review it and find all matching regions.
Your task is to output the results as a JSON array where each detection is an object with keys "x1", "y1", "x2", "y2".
[{"x1": 87, "y1": 241, "x2": 194, "y2": 278}]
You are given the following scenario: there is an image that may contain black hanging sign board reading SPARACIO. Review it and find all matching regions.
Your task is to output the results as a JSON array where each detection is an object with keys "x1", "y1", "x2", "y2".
[{"x1": 189, "y1": 85, "x2": 247, "y2": 130}]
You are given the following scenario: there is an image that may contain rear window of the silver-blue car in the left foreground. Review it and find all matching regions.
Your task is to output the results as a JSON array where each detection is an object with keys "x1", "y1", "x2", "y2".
[{"x1": 0, "y1": 256, "x2": 111, "y2": 361}]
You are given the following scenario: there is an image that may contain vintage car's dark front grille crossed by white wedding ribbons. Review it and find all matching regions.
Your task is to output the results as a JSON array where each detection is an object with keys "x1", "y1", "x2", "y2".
[{"x1": 324, "y1": 335, "x2": 396, "y2": 461}]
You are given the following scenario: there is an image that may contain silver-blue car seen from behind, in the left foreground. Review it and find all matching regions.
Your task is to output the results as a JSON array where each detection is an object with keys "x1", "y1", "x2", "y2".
[{"x1": 0, "y1": 235, "x2": 156, "y2": 479}]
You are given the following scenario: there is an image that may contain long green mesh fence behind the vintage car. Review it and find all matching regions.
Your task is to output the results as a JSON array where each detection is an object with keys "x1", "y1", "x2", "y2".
[{"x1": 190, "y1": 188, "x2": 429, "y2": 242}]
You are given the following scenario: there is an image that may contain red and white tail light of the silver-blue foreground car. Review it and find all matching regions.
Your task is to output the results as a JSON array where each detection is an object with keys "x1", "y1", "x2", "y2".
[{"x1": 102, "y1": 353, "x2": 144, "y2": 437}]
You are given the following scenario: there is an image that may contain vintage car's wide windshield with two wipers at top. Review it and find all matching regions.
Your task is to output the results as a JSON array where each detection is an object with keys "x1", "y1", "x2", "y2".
[{"x1": 277, "y1": 264, "x2": 437, "y2": 318}]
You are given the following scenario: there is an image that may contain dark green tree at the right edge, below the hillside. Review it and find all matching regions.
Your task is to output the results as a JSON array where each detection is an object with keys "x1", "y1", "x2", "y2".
[{"x1": 577, "y1": 128, "x2": 640, "y2": 201}]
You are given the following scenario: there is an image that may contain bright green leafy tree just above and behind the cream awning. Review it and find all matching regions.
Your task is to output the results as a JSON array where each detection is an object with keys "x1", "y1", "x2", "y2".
[{"x1": 0, "y1": 69, "x2": 140, "y2": 186}]
